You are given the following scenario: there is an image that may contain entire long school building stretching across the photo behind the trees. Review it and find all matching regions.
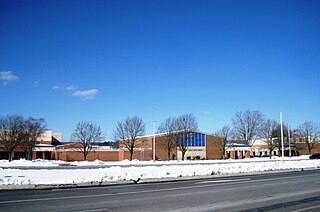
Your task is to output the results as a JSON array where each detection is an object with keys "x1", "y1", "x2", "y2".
[{"x1": 0, "y1": 131, "x2": 320, "y2": 161}]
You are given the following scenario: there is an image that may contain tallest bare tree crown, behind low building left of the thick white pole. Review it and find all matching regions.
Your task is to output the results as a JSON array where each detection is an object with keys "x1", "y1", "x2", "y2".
[{"x1": 232, "y1": 110, "x2": 264, "y2": 144}]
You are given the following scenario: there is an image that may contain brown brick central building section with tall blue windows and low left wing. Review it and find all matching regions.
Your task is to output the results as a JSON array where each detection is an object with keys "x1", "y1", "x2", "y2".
[{"x1": 56, "y1": 132, "x2": 223, "y2": 161}]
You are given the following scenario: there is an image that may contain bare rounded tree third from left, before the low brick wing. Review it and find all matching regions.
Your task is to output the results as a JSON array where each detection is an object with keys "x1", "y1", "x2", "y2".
[{"x1": 70, "y1": 122, "x2": 104, "y2": 160}]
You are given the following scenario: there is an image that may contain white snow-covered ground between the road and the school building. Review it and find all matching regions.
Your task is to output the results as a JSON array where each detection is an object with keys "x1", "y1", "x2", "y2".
[{"x1": 0, "y1": 156, "x2": 320, "y2": 185}]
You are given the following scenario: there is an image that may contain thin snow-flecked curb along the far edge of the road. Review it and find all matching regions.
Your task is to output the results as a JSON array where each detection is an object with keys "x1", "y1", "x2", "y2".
[{"x1": 0, "y1": 167, "x2": 320, "y2": 190}]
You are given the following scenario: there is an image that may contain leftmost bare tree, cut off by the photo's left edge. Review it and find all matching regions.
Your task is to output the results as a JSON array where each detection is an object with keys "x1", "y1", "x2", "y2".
[{"x1": 0, "y1": 115, "x2": 24, "y2": 161}]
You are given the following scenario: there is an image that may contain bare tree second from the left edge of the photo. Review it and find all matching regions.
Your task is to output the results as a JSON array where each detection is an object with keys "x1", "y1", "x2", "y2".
[{"x1": 19, "y1": 117, "x2": 46, "y2": 160}]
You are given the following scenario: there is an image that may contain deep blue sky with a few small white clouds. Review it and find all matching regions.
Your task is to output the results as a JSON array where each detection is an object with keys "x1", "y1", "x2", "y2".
[{"x1": 0, "y1": 0, "x2": 320, "y2": 141}]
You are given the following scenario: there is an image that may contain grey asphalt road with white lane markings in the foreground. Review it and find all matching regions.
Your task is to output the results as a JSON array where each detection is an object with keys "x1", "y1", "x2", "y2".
[{"x1": 0, "y1": 170, "x2": 320, "y2": 212}]
